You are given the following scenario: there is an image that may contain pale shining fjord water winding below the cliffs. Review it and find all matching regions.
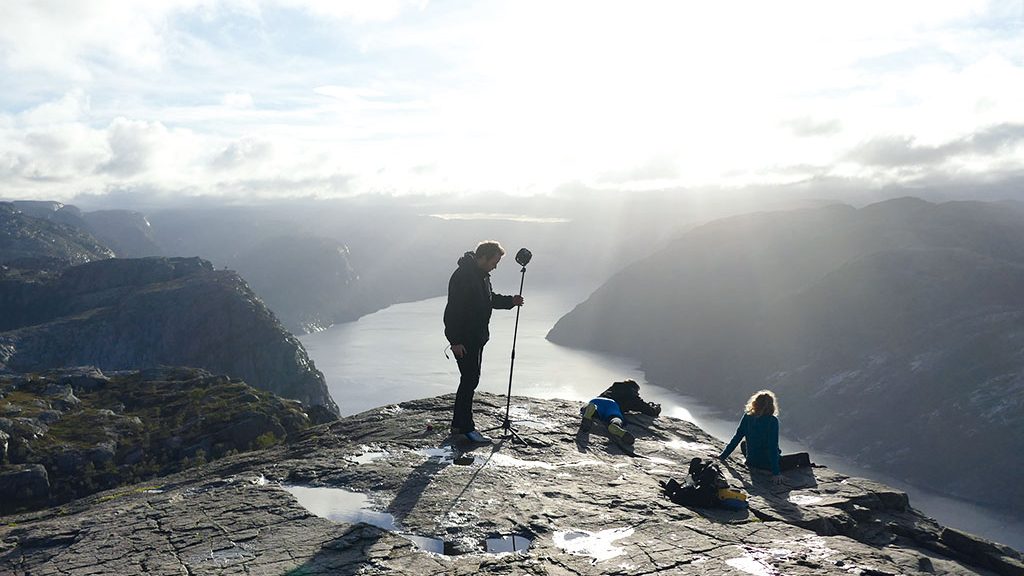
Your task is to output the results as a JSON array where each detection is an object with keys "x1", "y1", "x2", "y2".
[{"x1": 300, "y1": 287, "x2": 1024, "y2": 550}]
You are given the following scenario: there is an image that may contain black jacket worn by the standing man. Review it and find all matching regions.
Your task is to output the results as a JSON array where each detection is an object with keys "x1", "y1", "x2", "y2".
[{"x1": 444, "y1": 252, "x2": 512, "y2": 346}]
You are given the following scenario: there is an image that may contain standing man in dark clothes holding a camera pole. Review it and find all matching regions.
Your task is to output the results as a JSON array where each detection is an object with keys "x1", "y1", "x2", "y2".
[{"x1": 444, "y1": 241, "x2": 522, "y2": 444}]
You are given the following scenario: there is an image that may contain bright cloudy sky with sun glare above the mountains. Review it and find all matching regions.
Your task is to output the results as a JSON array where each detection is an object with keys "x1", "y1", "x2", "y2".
[{"x1": 0, "y1": 0, "x2": 1024, "y2": 201}]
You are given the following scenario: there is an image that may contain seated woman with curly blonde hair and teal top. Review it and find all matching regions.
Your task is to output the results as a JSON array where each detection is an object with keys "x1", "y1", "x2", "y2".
[{"x1": 718, "y1": 390, "x2": 811, "y2": 484}]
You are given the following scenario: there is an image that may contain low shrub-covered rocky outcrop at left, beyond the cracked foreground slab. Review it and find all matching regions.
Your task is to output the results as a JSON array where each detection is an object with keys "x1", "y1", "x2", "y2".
[{"x1": 0, "y1": 368, "x2": 327, "y2": 513}]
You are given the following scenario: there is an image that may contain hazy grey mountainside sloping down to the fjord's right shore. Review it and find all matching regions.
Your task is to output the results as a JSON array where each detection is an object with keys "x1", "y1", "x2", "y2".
[{"x1": 548, "y1": 199, "x2": 1024, "y2": 511}]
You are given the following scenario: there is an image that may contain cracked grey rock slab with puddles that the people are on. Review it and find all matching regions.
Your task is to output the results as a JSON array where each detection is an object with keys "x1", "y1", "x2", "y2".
[{"x1": 0, "y1": 394, "x2": 1024, "y2": 576}]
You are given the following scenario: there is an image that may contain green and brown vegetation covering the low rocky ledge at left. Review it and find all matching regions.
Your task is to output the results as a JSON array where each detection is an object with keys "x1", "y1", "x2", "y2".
[{"x1": 0, "y1": 368, "x2": 309, "y2": 503}]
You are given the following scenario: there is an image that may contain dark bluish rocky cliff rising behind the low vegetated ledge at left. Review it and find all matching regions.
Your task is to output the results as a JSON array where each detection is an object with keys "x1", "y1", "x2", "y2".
[{"x1": 0, "y1": 258, "x2": 338, "y2": 414}]
